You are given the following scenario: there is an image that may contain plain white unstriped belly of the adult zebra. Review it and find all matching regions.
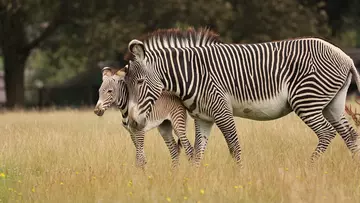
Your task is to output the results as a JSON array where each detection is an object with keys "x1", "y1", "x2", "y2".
[{"x1": 230, "y1": 90, "x2": 292, "y2": 121}]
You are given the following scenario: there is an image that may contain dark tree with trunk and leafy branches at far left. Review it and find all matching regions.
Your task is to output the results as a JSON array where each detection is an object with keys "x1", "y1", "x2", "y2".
[{"x1": 0, "y1": 0, "x2": 73, "y2": 108}]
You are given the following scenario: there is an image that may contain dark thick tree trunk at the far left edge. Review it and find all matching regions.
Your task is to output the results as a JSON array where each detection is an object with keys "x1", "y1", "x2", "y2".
[{"x1": 0, "y1": 5, "x2": 30, "y2": 108}]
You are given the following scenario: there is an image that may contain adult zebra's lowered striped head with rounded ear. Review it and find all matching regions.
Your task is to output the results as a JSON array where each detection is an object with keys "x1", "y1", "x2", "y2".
[{"x1": 125, "y1": 40, "x2": 163, "y2": 129}]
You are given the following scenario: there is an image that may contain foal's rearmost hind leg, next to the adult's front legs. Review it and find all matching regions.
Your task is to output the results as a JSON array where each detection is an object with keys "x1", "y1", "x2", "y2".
[{"x1": 172, "y1": 109, "x2": 194, "y2": 161}]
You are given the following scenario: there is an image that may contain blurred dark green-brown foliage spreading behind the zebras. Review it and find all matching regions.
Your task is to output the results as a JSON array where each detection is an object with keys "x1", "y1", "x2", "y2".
[{"x1": 10, "y1": 0, "x2": 360, "y2": 87}]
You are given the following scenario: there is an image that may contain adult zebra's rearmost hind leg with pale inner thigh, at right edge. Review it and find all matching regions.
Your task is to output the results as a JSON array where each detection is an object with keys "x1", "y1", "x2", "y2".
[{"x1": 323, "y1": 77, "x2": 360, "y2": 156}]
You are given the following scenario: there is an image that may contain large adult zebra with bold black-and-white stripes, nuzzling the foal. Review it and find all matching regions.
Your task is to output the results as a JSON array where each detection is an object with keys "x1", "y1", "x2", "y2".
[{"x1": 125, "y1": 29, "x2": 360, "y2": 165}]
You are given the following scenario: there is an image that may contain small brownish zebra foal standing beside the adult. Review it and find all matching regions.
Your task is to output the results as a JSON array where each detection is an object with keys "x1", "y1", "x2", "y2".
[{"x1": 94, "y1": 67, "x2": 193, "y2": 168}]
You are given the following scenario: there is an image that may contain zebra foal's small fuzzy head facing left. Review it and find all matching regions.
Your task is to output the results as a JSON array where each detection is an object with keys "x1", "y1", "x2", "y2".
[{"x1": 94, "y1": 67, "x2": 127, "y2": 116}]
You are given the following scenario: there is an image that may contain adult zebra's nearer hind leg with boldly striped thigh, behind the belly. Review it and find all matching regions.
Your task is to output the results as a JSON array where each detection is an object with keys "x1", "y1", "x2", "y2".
[{"x1": 289, "y1": 73, "x2": 345, "y2": 164}]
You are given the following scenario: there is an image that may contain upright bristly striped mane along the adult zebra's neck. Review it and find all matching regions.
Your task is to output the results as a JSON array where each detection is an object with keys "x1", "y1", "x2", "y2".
[{"x1": 124, "y1": 27, "x2": 222, "y2": 61}]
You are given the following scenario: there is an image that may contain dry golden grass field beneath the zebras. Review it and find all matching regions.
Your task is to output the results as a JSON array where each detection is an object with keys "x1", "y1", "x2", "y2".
[{"x1": 0, "y1": 109, "x2": 360, "y2": 203}]
